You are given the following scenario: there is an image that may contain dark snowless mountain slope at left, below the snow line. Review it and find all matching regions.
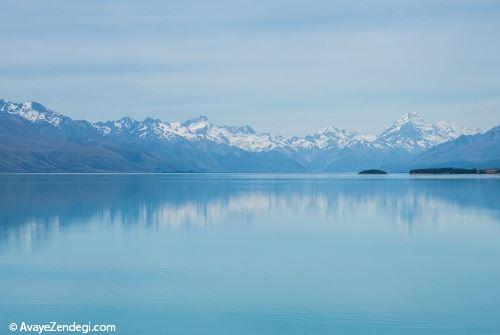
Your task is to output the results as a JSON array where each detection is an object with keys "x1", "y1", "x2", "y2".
[{"x1": 0, "y1": 113, "x2": 184, "y2": 172}]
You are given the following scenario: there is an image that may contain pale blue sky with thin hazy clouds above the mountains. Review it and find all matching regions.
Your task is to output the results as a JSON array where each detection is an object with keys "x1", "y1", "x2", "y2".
[{"x1": 0, "y1": 0, "x2": 500, "y2": 135}]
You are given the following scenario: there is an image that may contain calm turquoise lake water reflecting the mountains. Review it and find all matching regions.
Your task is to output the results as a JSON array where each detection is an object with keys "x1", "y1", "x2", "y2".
[{"x1": 0, "y1": 174, "x2": 500, "y2": 335}]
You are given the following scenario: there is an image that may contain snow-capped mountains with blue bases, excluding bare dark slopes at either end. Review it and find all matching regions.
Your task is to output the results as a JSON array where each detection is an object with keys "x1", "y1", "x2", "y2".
[{"x1": 0, "y1": 99, "x2": 492, "y2": 171}]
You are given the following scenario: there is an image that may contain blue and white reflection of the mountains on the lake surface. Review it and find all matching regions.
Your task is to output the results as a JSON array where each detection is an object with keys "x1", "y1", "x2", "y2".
[{"x1": 0, "y1": 174, "x2": 500, "y2": 250}]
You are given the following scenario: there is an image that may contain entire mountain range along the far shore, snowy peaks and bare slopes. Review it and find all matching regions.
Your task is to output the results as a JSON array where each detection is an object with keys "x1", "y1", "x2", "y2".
[{"x1": 0, "y1": 99, "x2": 500, "y2": 172}]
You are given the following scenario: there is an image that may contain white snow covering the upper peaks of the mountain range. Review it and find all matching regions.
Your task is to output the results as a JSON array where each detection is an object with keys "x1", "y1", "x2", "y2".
[{"x1": 0, "y1": 99, "x2": 482, "y2": 153}]
